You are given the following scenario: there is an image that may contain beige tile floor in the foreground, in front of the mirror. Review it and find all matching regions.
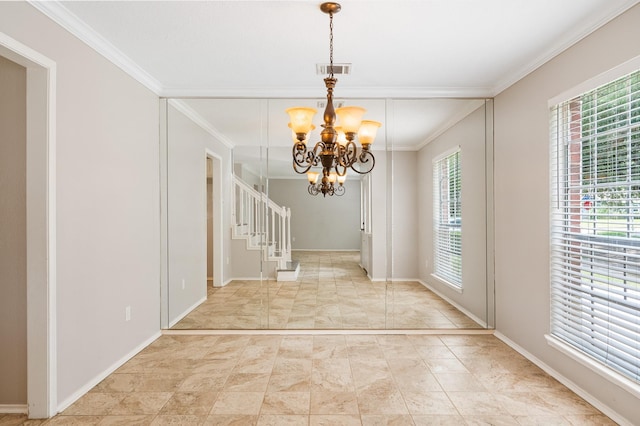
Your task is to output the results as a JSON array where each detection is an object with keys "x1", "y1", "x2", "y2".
[{"x1": 0, "y1": 334, "x2": 615, "y2": 426}]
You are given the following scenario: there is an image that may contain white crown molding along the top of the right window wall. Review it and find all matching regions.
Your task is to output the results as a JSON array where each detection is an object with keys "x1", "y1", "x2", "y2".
[{"x1": 486, "y1": 0, "x2": 640, "y2": 97}]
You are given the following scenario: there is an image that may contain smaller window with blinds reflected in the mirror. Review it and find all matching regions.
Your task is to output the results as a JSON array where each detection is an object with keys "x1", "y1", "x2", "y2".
[{"x1": 433, "y1": 148, "x2": 462, "y2": 287}]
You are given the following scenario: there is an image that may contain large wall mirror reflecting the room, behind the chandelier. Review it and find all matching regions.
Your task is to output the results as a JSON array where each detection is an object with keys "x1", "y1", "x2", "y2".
[{"x1": 163, "y1": 99, "x2": 493, "y2": 329}]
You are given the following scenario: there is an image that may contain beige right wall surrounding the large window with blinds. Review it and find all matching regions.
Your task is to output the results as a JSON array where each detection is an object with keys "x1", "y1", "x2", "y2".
[{"x1": 495, "y1": 5, "x2": 640, "y2": 424}]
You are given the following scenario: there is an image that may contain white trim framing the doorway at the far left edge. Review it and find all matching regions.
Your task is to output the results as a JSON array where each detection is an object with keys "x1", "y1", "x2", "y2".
[{"x1": 0, "y1": 32, "x2": 57, "y2": 418}]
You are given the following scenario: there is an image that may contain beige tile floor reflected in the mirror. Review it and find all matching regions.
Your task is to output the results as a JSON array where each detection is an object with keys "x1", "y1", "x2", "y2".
[{"x1": 173, "y1": 251, "x2": 480, "y2": 330}]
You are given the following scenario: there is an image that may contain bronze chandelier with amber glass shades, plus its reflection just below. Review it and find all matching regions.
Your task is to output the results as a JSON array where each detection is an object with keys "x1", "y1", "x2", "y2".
[{"x1": 287, "y1": 3, "x2": 381, "y2": 196}]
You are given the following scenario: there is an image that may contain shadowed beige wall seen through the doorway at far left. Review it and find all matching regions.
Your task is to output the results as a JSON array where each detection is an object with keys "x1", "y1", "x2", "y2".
[{"x1": 0, "y1": 56, "x2": 27, "y2": 405}]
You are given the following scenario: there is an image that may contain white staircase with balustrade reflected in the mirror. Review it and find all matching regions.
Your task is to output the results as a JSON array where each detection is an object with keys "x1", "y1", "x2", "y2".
[{"x1": 233, "y1": 176, "x2": 300, "y2": 281}]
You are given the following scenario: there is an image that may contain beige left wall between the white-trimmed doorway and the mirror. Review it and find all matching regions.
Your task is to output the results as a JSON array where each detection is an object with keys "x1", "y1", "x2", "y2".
[{"x1": 0, "y1": 2, "x2": 160, "y2": 408}]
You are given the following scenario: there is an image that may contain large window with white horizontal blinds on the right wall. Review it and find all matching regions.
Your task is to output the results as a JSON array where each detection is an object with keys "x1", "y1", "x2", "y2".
[{"x1": 551, "y1": 68, "x2": 640, "y2": 383}]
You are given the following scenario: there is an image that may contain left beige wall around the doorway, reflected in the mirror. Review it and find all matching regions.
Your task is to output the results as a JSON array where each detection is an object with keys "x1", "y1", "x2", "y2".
[{"x1": 167, "y1": 105, "x2": 233, "y2": 324}]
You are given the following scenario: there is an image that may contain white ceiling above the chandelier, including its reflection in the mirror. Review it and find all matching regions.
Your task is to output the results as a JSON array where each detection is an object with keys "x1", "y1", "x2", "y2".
[{"x1": 31, "y1": 0, "x2": 640, "y2": 172}]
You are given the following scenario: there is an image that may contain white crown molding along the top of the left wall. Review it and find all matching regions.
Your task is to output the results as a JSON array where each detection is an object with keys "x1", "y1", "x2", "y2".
[{"x1": 27, "y1": 0, "x2": 163, "y2": 96}]
